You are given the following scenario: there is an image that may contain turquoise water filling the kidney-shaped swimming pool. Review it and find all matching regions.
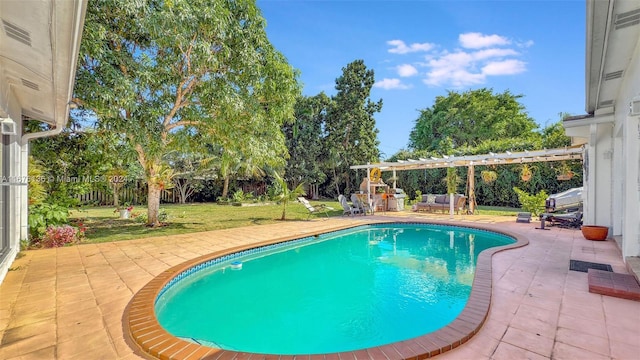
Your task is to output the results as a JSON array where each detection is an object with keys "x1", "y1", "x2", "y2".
[{"x1": 156, "y1": 224, "x2": 515, "y2": 355}]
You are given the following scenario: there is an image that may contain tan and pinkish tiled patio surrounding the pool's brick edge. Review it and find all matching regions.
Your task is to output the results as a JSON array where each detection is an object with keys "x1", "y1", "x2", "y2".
[{"x1": 0, "y1": 212, "x2": 640, "y2": 360}]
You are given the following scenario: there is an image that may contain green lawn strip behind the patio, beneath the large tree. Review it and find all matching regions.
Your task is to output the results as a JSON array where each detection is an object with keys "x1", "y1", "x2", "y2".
[{"x1": 70, "y1": 201, "x2": 342, "y2": 243}]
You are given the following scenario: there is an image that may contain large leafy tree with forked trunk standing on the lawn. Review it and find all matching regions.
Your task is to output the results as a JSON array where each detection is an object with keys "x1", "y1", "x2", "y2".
[{"x1": 75, "y1": 0, "x2": 298, "y2": 225}]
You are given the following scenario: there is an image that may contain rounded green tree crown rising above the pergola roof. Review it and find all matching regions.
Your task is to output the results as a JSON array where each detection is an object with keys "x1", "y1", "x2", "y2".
[{"x1": 409, "y1": 88, "x2": 537, "y2": 151}]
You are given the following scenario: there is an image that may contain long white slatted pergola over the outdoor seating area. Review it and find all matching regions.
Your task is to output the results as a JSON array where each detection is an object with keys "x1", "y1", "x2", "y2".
[{"x1": 350, "y1": 145, "x2": 584, "y2": 212}]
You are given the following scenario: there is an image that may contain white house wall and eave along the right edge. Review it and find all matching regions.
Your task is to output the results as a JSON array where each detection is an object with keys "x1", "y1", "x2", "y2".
[{"x1": 564, "y1": 0, "x2": 640, "y2": 269}]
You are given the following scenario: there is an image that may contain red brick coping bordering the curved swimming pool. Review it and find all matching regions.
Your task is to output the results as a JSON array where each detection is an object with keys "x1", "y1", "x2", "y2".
[{"x1": 123, "y1": 221, "x2": 529, "y2": 360}]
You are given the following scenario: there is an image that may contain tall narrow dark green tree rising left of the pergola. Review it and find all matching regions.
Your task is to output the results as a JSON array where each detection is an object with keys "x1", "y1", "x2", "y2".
[{"x1": 325, "y1": 60, "x2": 382, "y2": 195}]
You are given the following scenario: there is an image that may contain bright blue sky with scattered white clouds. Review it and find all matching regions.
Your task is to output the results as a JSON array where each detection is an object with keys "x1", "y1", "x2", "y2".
[{"x1": 257, "y1": 0, "x2": 586, "y2": 159}]
